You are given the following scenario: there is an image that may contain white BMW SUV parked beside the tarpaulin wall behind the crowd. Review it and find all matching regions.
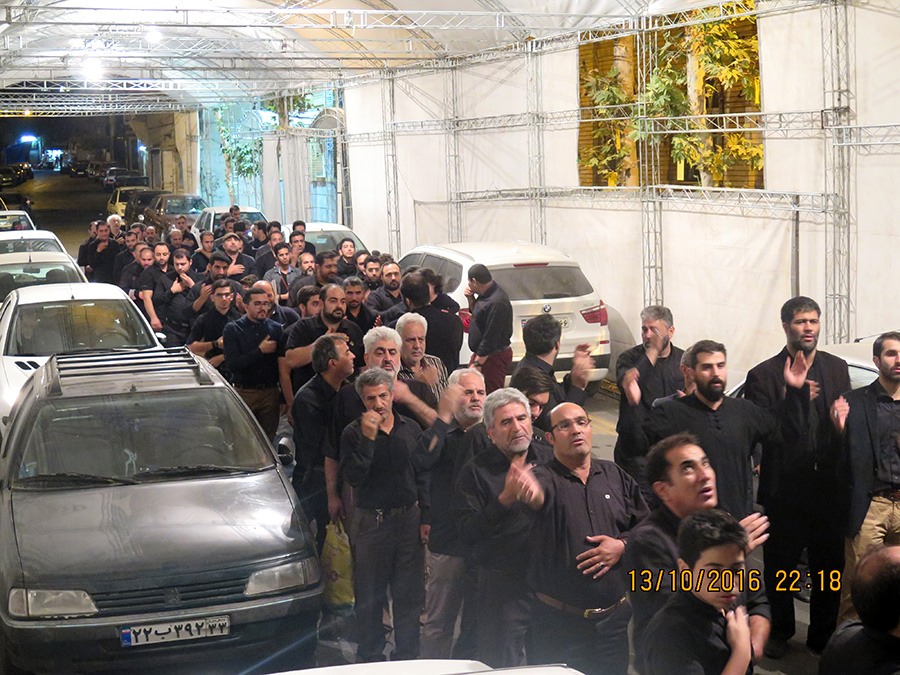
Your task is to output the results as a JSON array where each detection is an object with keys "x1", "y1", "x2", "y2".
[{"x1": 400, "y1": 242, "x2": 610, "y2": 381}]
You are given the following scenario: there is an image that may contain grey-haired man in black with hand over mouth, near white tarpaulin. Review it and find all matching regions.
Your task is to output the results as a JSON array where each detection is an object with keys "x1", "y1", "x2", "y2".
[{"x1": 613, "y1": 305, "x2": 684, "y2": 504}]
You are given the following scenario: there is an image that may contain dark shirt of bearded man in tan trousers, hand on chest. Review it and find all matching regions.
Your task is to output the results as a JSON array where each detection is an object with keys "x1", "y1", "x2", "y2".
[{"x1": 222, "y1": 315, "x2": 282, "y2": 389}]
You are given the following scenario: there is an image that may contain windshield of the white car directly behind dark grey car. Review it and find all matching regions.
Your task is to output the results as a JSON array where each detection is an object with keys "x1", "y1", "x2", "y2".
[{"x1": 6, "y1": 300, "x2": 157, "y2": 356}]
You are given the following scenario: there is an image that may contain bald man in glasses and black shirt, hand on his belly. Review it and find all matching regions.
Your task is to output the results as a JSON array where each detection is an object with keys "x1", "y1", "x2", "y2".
[{"x1": 519, "y1": 403, "x2": 647, "y2": 675}]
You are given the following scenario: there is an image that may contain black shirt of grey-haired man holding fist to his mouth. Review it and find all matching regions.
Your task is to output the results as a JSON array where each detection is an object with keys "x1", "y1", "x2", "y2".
[{"x1": 341, "y1": 414, "x2": 422, "y2": 509}]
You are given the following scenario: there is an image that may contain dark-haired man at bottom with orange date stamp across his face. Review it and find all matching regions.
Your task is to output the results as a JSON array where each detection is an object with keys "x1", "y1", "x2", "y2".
[{"x1": 643, "y1": 509, "x2": 753, "y2": 675}]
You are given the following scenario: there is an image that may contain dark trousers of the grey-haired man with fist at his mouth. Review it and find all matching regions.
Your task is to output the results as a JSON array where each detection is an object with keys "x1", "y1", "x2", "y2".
[{"x1": 350, "y1": 506, "x2": 425, "y2": 662}]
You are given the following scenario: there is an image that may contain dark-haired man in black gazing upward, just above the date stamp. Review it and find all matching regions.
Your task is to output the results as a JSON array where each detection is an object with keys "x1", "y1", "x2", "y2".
[{"x1": 624, "y1": 434, "x2": 770, "y2": 668}]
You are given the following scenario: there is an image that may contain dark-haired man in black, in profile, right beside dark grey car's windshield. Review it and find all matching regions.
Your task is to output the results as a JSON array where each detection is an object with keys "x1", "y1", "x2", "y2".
[{"x1": 291, "y1": 333, "x2": 353, "y2": 555}]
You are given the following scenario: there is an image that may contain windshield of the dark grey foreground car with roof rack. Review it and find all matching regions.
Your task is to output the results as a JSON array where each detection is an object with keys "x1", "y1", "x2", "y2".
[{"x1": 14, "y1": 388, "x2": 274, "y2": 488}]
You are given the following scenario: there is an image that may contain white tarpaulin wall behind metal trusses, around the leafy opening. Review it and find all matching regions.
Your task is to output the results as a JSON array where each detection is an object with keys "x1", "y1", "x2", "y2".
[{"x1": 345, "y1": 5, "x2": 900, "y2": 371}]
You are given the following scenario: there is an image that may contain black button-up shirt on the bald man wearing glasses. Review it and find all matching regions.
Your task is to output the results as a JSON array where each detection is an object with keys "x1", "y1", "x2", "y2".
[{"x1": 528, "y1": 458, "x2": 649, "y2": 609}]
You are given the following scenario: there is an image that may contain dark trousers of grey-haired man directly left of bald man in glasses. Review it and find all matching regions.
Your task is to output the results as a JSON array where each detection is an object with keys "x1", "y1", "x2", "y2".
[{"x1": 476, "y1": 568, "x2": 532, "y2": 668}]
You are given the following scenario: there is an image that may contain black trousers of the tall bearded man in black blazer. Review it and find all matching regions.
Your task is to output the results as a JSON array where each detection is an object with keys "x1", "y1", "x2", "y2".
[{"x1": 763, "y1": 510, "x2": 844, "y2": 650}]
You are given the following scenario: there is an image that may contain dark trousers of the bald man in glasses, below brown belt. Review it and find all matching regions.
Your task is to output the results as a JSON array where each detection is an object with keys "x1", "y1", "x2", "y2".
[{"x1": 528, "y1": 600, "x2": 631, "y2": 675}]
